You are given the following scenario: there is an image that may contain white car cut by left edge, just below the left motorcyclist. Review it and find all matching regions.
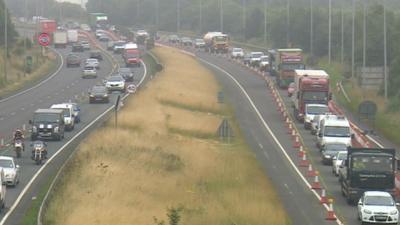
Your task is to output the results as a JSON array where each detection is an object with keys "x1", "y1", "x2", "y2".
[{"x1": 0, "y1": 156, "x2": 20, "y2": 186}]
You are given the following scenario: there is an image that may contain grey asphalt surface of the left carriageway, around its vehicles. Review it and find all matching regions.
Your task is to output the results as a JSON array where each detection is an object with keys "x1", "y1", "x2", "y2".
[{"x1": 0, "y1": 34, "x2": 145, "y2": 224}]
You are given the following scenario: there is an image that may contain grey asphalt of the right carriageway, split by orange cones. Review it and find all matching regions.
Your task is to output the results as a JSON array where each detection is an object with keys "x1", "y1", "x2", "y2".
[{"x1": 158, "y1": 39, "x2": 398, "y2": 224}]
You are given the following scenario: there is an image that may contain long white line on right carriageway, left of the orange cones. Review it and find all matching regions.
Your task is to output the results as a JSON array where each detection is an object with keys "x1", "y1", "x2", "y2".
[{"x1": 197, "y1": 57, "x2": 343, "y2": 225}]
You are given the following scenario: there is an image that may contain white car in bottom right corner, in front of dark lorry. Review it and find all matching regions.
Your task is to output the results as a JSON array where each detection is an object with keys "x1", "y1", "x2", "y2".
[{"x1": 357, "y1": 191, "x2": 399, "y2": 224}]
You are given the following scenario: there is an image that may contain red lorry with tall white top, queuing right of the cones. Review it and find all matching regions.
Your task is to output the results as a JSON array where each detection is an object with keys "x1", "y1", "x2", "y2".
[{"x1": 292, "y1": 70, "x2": 331, "y2": 121}]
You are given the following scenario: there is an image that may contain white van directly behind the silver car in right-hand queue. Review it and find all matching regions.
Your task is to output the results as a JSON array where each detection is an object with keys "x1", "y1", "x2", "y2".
[{"x1": 317, "y1": 115, "x2": 352, "y2": 148}]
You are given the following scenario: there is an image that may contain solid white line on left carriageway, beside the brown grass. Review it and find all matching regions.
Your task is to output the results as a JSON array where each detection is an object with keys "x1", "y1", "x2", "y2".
[{"x1": 0, "y1": 52, "x2": 147, "y2": 225}]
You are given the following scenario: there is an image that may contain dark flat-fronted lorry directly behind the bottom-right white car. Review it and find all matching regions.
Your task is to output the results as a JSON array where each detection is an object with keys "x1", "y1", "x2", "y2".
[{"x1": 339, "y1": 147, "x2": 397, "y2": 204}]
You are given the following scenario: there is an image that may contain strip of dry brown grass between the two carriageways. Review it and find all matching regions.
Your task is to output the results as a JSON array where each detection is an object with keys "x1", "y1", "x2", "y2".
[{"x1": 45, "y1": 48, "x2": 289, "y2": 225}]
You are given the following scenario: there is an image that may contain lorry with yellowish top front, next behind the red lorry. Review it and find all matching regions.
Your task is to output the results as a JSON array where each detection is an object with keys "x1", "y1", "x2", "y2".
[{"x1": 275, "y1": 48, "x2": 305, "y2": 88}]
